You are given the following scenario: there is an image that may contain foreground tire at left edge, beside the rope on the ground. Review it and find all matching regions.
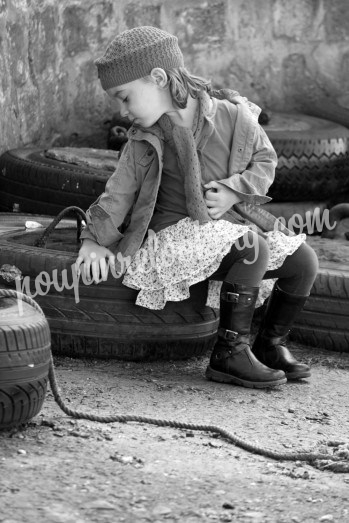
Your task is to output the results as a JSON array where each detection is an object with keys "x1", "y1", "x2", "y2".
[{"x1": 0, "y1": 289, "x2": 51, "y2": 430}]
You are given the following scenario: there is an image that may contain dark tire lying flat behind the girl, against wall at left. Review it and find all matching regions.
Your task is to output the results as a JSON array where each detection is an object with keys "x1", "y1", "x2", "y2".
[{"x1": 0, "y1": 148, "x2": 111, "y2": 215}]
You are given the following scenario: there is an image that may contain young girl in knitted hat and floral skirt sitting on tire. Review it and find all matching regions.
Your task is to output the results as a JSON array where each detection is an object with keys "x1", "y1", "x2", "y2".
[{"x1": 76, "y1": 26, "x2": 318, "y2": 388}]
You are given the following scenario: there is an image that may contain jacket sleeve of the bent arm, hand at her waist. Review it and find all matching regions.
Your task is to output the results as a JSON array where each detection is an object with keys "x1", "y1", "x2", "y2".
[{"x1": 219, "y1": 112, "x2": 277, "y2": 204}]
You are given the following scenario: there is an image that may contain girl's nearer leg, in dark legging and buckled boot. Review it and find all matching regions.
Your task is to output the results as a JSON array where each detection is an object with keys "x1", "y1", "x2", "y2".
[{"x1": 206, "y1": 232, "x2": 286, "y2": 388}]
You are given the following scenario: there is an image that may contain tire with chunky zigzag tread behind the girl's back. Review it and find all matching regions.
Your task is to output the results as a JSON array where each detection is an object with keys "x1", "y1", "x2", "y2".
[{"x1": 264, "y1": 112, "x2": 349, "y2": 201}]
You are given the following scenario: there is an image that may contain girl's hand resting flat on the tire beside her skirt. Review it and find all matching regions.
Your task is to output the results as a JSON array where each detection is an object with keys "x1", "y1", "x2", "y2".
[{"x1": 75, "y1": 239, "x2": 115, "y2": 283}]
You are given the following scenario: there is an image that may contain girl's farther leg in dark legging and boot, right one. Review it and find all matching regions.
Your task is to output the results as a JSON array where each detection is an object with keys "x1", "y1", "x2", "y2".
[{"x1": 252, "y1": 243, "x2": 319, "y2": 379}]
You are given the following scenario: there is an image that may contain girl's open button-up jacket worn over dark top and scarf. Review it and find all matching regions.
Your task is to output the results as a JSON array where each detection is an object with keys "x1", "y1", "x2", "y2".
[{"x1": 81, "y1": 97, "x2": 288, "y2": 264}]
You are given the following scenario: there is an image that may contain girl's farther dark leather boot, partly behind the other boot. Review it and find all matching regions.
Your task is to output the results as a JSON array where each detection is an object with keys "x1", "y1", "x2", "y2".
[{"x1": 252, "y1": 284, "x2": 310, "y2": 380}]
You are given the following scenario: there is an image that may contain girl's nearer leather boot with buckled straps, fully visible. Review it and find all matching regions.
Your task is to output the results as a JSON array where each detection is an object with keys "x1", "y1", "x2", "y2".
[{"x1": 206, "y1": 282, "x2": 287, "y2": 388}]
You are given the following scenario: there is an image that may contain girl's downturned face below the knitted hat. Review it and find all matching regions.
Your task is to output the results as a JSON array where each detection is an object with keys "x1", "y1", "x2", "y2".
[{"x1": 107, "y1": 78, "x2": 173, "y2": 127}]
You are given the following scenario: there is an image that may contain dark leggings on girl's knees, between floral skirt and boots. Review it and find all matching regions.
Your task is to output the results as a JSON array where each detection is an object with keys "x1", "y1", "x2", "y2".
[{"x1": 210, "y1": 231, "x2": 319, "y2": 296}]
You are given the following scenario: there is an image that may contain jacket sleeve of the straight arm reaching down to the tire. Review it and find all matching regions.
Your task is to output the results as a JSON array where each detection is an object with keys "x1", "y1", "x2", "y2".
[{"x1": 80, "y1": 143, "x2": 138, "y2": 247}]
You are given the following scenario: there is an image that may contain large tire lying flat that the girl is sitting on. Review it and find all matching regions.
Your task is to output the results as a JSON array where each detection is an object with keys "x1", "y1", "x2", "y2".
[{"x1": 0, "y1": 229, "x2": 218, "y2": 361}]
